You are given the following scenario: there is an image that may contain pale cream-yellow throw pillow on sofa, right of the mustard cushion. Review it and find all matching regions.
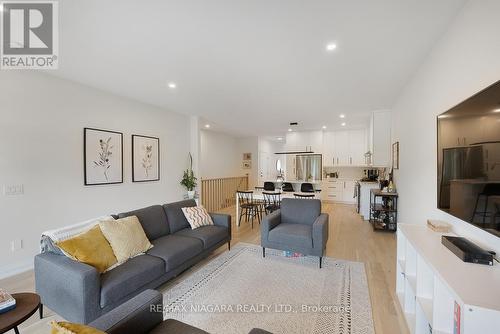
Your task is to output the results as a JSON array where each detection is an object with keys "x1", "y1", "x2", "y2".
[{"x1": 99, "y1": 216, "x2": 153, "y2": 263}]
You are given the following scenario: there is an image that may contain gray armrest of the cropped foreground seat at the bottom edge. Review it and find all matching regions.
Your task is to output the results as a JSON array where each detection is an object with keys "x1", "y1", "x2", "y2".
[{"x1": 89, "y1": 290, "x2": 163, "y2": 334}]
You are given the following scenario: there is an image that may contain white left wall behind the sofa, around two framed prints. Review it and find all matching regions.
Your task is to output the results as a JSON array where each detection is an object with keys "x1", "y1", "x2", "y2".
[{"x1": 0, "y1": 71, "x2": 190, "y2": 277}]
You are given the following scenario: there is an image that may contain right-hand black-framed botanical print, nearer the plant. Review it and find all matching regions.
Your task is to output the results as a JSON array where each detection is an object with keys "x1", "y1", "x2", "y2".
[{"x1": 132, "y1": 135, "x2": 160, "y2": 182}]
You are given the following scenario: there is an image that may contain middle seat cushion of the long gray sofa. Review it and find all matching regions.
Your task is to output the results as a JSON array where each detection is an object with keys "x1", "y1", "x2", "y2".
[{"x1": 148, "y1": 235, "x2": 203, "y2": 272}]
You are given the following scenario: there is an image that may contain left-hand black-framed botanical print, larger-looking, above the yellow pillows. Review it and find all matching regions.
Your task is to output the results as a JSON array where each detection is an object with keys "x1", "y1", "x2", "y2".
[{"x1": 83, "y1": 128, "x2": 123, "y2": 186}]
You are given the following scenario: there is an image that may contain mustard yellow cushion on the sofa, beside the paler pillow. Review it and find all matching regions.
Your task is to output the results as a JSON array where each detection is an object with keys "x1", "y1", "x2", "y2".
[{"x1": 56, "y1": 225, "x2": 117, "y2": 273}]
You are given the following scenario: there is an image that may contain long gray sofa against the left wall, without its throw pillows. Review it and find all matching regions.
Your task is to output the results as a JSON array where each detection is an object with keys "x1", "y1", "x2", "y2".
[{"x1": 35, "y1": 200, "x2": 231, "y2": 324}]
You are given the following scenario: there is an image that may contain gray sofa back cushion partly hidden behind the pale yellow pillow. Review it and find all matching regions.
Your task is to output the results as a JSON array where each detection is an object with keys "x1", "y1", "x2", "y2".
[{"x1": 118, "y1": 205, "x2": 170, "y2": 240}]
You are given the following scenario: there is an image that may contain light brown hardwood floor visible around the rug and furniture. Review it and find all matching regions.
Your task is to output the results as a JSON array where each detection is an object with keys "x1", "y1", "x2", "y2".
[{"x1": 0, "y1": 203, "x2": 409, "y2": 334}]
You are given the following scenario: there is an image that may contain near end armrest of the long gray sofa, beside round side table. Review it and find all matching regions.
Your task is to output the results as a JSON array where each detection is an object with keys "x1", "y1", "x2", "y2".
[{"x1": 35, "y1": 253, "x2": 101, "y2": 324}]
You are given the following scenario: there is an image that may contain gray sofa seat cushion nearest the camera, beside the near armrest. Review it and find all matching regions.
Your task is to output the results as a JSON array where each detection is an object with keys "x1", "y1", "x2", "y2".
[{"x1": 101, "y1": 255, "x2": 165, "y2": 307}]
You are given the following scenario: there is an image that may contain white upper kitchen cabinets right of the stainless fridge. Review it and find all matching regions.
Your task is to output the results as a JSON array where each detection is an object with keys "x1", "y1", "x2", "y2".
[{"x1": 323, "y1": 129, "x2": 368, "y2": 166}]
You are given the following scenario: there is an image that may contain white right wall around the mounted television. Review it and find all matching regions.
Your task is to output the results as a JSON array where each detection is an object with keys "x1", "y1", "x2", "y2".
[{"x1": 393, "y1": 0, "x2": 500, "y2": 252}]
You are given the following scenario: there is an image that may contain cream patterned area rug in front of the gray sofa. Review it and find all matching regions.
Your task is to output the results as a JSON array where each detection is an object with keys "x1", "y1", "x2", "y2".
[{"x1": 161, "y1": 243, "x2": 374, "y2": 334}]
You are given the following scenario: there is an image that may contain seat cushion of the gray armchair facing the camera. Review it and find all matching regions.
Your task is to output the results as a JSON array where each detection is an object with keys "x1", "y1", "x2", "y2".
[{"x1": 269, "y1": 223, "x2": 312, "y2": 248}]
